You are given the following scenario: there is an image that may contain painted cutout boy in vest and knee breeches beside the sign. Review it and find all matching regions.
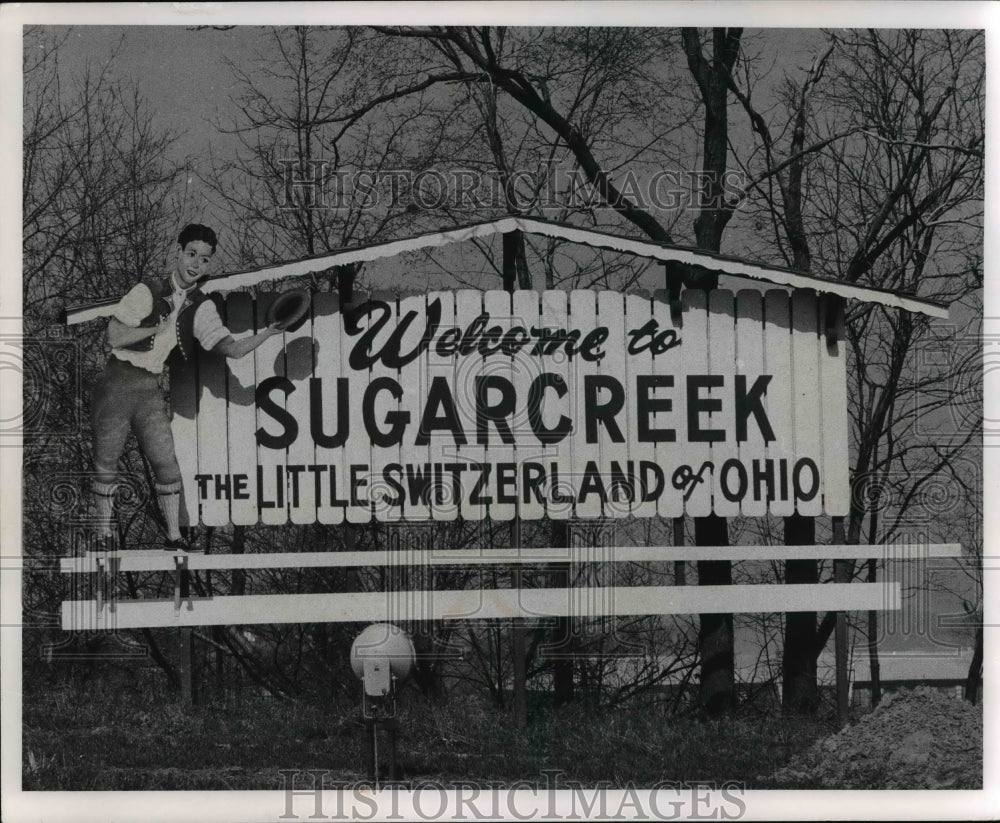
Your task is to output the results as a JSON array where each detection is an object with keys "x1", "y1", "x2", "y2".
[{"x1": 91, "y1": 224, "x2": 281, "y2": 551}]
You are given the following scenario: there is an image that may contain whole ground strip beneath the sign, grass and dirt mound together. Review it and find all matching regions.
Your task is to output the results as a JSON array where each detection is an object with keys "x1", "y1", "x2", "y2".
[{"x1": 22, "y1": 681, "x2": 982, "y2": 791}]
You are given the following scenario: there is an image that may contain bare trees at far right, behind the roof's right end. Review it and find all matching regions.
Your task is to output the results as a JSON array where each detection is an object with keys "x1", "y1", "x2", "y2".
[{"x1": 733, "y1": 31, "x2": 983, "y2": 712}]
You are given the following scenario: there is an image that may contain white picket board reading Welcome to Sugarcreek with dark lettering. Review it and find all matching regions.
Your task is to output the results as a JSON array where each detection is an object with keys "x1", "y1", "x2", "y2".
[{"x1": 171, "y1": 290, "x2": 849, "y2": 525}]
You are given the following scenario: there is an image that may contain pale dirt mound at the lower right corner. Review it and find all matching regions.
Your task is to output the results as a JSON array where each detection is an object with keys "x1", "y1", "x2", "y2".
[{"x1": 774, "y1": 688, "x2": 983, "y2": 789}]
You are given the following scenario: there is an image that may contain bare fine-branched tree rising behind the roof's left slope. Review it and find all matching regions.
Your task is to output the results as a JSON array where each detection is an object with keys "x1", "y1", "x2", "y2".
[{"x1": 210, "y1": 26, "x2": 498, "y2": 276}]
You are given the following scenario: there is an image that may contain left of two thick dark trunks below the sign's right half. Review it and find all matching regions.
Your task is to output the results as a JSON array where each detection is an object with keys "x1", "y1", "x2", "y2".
[{"x1": 694, "y1": 515, "x2": 736, "y2": 717}]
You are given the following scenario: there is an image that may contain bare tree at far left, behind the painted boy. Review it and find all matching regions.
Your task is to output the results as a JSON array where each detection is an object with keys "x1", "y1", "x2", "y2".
[{"x1": 22, "y1": 28, "x2": 184, "y2": 675}]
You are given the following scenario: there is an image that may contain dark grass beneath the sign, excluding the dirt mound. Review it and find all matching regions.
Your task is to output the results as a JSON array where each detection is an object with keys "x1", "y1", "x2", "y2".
[{"x1": 23, "y1": 685, "x2": 830, "y2": 791}]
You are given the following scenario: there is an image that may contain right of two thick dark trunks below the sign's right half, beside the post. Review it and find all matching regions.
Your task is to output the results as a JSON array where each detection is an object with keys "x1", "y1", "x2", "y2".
[{"x1": 781, "y1": 515, "x2": 819, "y2": 714}]
